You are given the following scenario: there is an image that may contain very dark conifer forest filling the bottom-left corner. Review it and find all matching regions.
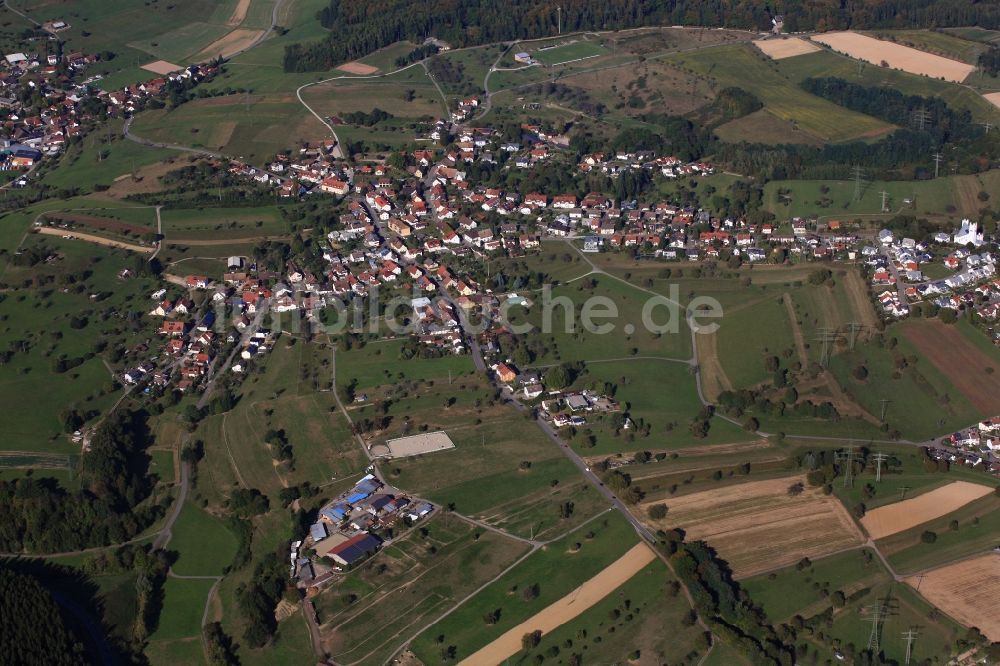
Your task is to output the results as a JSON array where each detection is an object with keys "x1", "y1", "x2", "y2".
[{"x1": 0, "y1": 567, "x2": 89, "y2": 666}]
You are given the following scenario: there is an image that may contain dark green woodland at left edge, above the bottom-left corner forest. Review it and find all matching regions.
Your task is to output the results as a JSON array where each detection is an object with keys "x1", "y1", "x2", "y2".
[{"x1": 0, "y1": 410, "x2": 163, "y2": 553}]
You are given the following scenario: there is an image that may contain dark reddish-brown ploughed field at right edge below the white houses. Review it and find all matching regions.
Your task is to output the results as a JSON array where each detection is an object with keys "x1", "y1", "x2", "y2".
[{"x1": 903, "y1": 319, "x2": 1000, "y2": 416}]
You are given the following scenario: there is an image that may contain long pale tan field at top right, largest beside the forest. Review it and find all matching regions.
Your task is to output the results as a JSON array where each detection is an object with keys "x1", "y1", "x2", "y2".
[{"x1": 812, "y1": 32, "x2": 975, "y2": 83}]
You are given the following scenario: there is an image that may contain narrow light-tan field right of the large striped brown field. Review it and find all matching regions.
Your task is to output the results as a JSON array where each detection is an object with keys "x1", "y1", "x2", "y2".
[{"x1": 861, "y1": 481, "x2": 993, "y2": 539}]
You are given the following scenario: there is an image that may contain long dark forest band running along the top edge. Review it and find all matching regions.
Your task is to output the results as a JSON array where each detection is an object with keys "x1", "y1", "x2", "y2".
[{"x1": 284, "y1": 0, "x2": 1000, "y2": 72}]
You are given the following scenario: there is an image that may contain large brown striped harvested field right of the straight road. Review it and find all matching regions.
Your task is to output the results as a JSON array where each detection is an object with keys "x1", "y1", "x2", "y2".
[{"x1": 640, "y1": 476, "x2": 864, "y2": 578}]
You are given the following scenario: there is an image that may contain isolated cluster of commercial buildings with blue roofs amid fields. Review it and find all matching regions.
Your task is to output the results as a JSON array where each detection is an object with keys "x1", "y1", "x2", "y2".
[{"x1": 289, "y1": 474, "x2": 434, "y2": 587}]
